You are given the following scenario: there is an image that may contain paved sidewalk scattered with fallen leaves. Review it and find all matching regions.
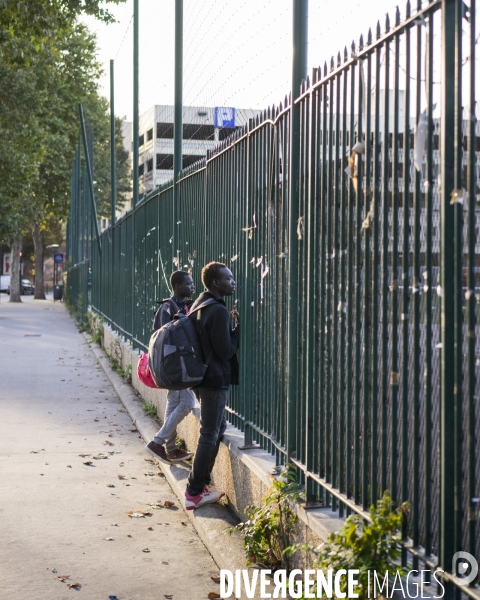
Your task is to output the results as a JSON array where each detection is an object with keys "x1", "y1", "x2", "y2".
[{"x1": 0, "y1": 294, "x2": 219, "y2": 600}]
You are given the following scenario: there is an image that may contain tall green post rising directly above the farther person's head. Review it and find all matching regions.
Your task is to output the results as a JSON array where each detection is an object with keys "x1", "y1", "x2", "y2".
[{"x1": 172, "y1": 0, "x2": 183, "y2": 268}]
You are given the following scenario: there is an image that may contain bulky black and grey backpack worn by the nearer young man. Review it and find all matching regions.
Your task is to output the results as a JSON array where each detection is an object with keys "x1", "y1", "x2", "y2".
[{"x1": 148, "y1": 298, "x2": 217, "y2": 390}]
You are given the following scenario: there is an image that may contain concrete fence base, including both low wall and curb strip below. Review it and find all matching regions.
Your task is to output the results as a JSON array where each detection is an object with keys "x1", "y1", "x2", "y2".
[{"x1": 85, "y1": 323, "x2": 344, "y2": 570}]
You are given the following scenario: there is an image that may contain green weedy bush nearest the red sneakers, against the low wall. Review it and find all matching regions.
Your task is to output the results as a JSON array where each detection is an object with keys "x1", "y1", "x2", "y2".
[{"x1": 227, "y1": 467, "x2": 301, "y2": 570}]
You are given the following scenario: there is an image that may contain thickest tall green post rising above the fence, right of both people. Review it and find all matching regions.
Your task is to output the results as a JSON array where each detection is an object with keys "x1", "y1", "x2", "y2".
[{"x1": 286, "y1": 0, "x2": 308, "y2": 460}]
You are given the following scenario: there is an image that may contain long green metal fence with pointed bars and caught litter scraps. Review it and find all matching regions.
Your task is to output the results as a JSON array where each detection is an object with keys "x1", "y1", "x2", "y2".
[{"x1": 68, "y1": 0, "x2": 480, "y2": 598}]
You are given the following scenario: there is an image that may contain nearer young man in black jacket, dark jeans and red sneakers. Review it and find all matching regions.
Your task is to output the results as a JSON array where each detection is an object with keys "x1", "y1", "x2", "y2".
[{"x1": 185, "y1": 262, "x2": 240, "y2": 510}]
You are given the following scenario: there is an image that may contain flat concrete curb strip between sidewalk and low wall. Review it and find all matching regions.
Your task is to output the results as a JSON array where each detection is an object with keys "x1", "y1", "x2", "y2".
[{"x1": 83, "y1": 333, "x2": 256, "y2": 592}]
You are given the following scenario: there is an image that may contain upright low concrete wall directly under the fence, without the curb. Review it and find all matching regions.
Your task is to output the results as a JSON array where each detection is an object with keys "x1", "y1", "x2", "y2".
[{"x1": 98, "y1": 324, "x2": 344, "y2": 568}]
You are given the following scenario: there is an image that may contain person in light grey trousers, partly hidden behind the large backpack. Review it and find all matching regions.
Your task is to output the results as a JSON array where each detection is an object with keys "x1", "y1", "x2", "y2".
[{"x1": 145, "y1": 271, "x2": 195, "y2": 463}]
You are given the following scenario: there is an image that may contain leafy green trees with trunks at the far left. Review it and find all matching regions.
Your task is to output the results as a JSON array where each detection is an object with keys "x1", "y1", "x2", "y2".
[{"x1": 0, "y1": 0, "x2": 124, "y2": 301}]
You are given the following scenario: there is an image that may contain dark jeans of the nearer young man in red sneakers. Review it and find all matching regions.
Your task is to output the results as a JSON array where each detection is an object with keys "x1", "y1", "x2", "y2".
[{"x1": 187, "y1": 388, "x2": 228, "y2": 496}]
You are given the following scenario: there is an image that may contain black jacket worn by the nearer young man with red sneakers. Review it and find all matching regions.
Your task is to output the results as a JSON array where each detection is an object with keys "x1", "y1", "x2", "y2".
[{"x1": 190, "y1": 292, "x2": 240, "y2": 388}]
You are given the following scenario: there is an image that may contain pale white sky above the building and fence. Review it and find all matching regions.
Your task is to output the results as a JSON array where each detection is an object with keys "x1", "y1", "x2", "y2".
[{"x1": 84, "y1": 0, "x2": 405, "y2": 120}]
